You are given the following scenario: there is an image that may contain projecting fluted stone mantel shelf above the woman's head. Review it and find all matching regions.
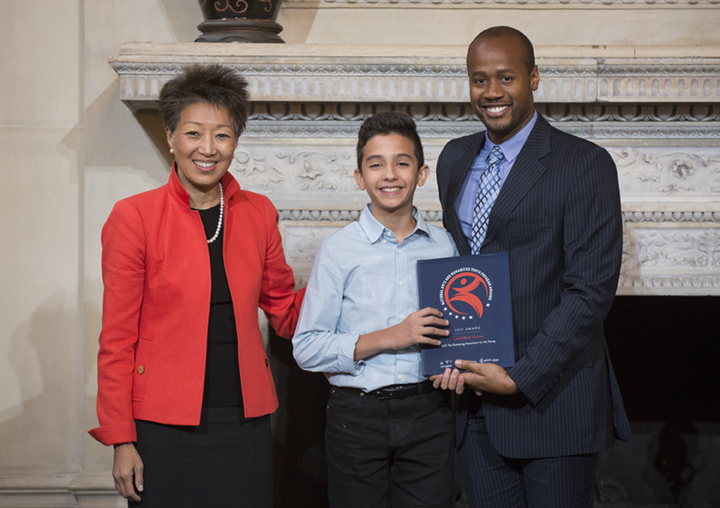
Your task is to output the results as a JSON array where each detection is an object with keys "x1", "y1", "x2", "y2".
[{"x1": 110, "y1": 44, "x2": 720, "y2": 110}]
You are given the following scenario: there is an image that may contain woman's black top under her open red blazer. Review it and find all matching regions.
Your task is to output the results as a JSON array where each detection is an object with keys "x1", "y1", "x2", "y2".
[{"x1": 198, "y1": 204, "x2": 242, "y2": 407}]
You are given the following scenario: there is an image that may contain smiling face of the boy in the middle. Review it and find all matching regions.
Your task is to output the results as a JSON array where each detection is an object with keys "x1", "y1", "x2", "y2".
[{"x1": 355, "y1": 133, "x2": 430, "y2": 222}]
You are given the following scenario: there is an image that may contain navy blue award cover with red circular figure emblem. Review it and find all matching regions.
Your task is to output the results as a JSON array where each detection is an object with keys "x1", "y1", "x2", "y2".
[{"x1": 417, "y1": 252, "x2": 515, "y2": 376}]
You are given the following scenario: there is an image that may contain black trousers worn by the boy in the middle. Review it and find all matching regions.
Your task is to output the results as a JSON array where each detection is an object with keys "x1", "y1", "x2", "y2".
[{"x1": 325, "y1": 381, "x2": 455, "y2": 508}]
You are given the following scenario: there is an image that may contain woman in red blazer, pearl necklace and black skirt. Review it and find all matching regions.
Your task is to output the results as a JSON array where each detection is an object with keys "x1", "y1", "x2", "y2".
[{"x1": 90, "y1": 65, "x2": 302, "y2": 508}]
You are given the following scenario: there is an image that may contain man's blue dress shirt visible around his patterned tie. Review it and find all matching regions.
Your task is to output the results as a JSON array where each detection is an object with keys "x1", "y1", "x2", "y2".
[{"x1": 455, "y1": 111, "x2": 537, "y2": 242}]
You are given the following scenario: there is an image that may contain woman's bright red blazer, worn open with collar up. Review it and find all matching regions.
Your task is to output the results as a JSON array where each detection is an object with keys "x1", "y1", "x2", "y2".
[{"x1": 90, "y1": 168, "x2": 304, "y2": 445}]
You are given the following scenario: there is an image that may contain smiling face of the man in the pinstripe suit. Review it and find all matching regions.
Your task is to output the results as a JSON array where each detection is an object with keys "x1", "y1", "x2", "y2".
[{"x1": 467, "y1": 35, "x2": 540, "y2": 144}]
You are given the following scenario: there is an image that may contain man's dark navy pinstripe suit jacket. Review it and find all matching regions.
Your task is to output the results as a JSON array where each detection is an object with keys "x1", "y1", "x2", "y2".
[{"x1": 437, "y1": 116, "x2": 631, "y2": 458}]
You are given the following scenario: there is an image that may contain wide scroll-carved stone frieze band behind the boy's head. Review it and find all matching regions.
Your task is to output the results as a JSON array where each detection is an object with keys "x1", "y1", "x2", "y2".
[{"x1": 231, "y1": 143, "x2": 720, "y2": 202}]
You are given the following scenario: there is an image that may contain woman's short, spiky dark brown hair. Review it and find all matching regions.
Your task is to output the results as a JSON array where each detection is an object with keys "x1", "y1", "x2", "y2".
[{"x1": 159, "y1": 64, "x2": 248, "y2": 138}]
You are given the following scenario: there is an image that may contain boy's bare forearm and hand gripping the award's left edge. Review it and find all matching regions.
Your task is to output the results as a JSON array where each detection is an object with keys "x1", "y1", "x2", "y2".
[{"x1": 354, "y1": 307, "x2": 450, "y2": 361}]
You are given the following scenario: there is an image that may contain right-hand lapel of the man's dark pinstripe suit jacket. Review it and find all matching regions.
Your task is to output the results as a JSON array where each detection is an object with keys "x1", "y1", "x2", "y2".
[{"x1": 483, "y1": 115, "x2": 550, "y2": 245}]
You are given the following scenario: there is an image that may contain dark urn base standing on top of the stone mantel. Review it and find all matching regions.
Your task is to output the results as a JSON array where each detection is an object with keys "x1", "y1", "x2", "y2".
[{"x1": 200, "y1": 0, "x2": 285, "y2": 43}]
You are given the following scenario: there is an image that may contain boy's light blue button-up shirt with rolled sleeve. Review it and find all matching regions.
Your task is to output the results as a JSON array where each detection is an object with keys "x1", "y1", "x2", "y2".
[{"x1": 292, "y1": 205, "x2": 457, "y2": 392}]
